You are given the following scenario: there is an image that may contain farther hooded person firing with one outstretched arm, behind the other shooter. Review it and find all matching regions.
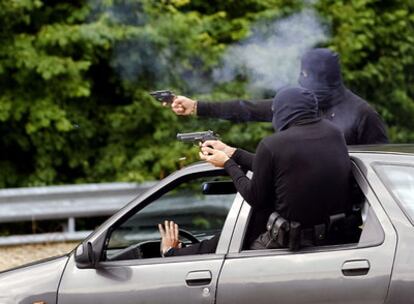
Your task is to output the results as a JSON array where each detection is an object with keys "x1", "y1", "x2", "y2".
[{"x1": 167, "y1": 48, "x2": 388, "y2": 145}]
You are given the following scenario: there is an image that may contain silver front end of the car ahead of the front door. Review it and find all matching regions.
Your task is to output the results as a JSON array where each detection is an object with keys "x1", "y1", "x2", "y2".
[{"x1": 0, "y1": 255, "x2": 69, "y2": 304}]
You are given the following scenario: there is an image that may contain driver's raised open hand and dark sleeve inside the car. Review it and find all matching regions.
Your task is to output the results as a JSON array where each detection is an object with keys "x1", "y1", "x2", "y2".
[{"x1": 158, "y1": 221, "x2": 220, "y2": 257}]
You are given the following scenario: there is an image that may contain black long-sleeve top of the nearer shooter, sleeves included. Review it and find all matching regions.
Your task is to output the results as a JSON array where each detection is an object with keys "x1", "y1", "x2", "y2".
[{"x1": 225, "y1": 119, "x2": 351, "y2": 230}]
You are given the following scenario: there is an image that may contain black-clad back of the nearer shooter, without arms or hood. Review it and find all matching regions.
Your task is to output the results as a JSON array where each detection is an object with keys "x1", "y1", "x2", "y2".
[{"x1": 263, "y1": 120, "x2": 351, "y2": 227}]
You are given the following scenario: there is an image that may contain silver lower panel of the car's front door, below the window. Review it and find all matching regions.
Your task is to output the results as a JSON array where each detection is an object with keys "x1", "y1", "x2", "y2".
[{"x1": 58, "y1": 254, "x2": 224, "y2": 304}]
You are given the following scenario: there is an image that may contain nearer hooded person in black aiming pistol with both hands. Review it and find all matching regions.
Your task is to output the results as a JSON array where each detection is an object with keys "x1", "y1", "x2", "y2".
[{"x1": 200, "y1": 87, "x2": 351, "y2": 248}]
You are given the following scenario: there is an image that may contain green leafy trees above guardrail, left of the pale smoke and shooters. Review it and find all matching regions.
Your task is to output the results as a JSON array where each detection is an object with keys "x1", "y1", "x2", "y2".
[{"x1": 0, "y1": 0, "x2": 298, "y2": 187}]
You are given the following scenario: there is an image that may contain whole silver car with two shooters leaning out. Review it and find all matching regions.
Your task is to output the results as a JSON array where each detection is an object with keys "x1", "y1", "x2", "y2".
[{"x1": 0, "y1": 145, "x2": 414, "y2": 304}]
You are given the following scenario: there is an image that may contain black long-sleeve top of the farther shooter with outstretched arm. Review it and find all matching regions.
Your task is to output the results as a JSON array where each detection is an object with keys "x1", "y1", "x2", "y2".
[{"x1": 197, "y1": 89, "x2": 388, "y2": 145}]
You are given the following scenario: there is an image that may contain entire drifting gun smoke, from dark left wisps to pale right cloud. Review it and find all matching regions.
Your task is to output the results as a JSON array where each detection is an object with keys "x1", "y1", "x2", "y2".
[{"x1": 90, "y1": 0, "x2": 328, "y2": 94}]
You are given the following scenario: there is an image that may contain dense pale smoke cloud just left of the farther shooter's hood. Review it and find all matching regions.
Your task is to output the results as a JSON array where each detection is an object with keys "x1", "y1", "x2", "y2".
[{"x1": 213, "y1": 9, "x2": 328, "y2": 91}]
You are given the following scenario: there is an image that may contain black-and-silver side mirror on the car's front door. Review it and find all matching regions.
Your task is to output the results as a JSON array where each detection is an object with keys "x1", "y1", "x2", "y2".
[{"x1": 75, "y1": 234, "x2": 105, "y2": 269}]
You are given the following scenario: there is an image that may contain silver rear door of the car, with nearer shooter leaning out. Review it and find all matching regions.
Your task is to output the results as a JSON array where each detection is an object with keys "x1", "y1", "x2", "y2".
[{"x1": 217, "y1": 160, "x2": 396, "y2": 304}]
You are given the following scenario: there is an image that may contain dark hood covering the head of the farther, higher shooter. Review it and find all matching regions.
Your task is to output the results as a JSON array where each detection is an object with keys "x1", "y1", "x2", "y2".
[{"x1": 299, "y1": 48, "x2": 345, "y2": 109}]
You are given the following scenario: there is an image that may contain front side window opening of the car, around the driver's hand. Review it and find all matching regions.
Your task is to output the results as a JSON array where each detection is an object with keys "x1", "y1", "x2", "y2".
[{"x1": 106, "y1": 177, "x2": 236, "y2": 260}]
